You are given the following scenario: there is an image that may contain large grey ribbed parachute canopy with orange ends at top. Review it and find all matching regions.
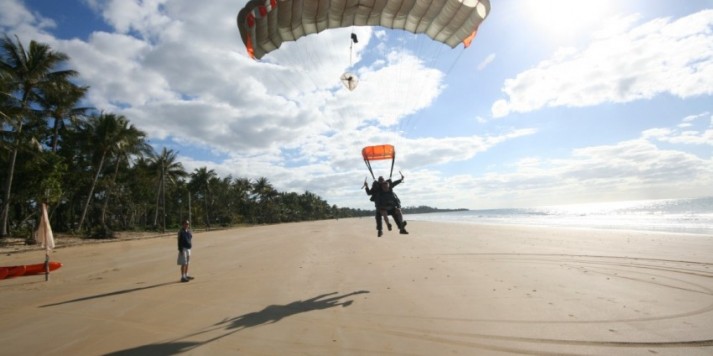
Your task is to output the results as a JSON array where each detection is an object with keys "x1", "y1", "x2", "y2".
[{"x1": 237, "y1": 0, "x2": 490, "y2": 59}]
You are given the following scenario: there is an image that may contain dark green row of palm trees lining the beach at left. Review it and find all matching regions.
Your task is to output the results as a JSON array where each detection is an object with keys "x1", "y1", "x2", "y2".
[{"x1": 0, "y1": 34, "x2": 373, "y2": 238}]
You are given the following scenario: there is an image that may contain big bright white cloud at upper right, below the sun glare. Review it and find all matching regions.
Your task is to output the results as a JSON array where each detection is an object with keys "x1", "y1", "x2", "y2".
[{"x1": 491, "y1": 10, "x2": 713, "y2": 117}]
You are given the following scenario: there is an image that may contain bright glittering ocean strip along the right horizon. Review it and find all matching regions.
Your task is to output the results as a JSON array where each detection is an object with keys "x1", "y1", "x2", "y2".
[{"x1": 404, "y1": 197, "x2": 713, "y2": 236}]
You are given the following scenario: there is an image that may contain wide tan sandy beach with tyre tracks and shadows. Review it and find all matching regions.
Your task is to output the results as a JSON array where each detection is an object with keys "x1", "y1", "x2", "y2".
[{"x1": 0, "y1": 218, "x2": 713, "y2": 355}]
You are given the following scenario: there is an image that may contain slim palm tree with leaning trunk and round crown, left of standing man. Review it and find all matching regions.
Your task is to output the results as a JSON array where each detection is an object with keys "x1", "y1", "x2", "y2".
[{"x1": 77, "y1": 113, "x2": 129, "y2": 231}]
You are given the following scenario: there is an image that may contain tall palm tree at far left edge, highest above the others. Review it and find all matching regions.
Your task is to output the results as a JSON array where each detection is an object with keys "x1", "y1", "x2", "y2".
[{"x1": 0, "y1": 35, "x2": 78, "y2": 237}]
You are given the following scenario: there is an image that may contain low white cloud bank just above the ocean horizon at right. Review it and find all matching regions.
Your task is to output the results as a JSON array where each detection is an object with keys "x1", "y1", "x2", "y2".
[{"x1": 444, "y1": 140, "x2": 713, "y2": 208}]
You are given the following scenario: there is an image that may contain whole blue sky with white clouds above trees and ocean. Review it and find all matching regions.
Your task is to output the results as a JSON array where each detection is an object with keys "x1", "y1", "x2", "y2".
[{"x1": 0, "y1": 0, "x2": 713, "y2": 209}]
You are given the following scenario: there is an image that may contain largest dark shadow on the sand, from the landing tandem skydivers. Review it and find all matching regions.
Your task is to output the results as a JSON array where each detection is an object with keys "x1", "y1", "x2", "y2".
[{"x1": 106, "y1": 290, "x2": 369, "y2": 356}]
